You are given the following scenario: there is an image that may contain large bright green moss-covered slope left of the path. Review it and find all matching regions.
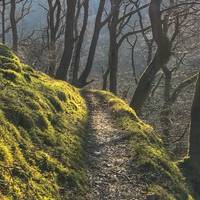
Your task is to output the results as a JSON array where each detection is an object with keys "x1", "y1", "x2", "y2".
[{"x1": 0, "y1": 45, "x2": 87, "y2": 200}]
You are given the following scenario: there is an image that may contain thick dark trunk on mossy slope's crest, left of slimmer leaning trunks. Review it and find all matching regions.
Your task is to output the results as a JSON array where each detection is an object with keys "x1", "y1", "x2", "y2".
[{"x1": 56, "y1": 0, "x2": 77, "y2": 80}]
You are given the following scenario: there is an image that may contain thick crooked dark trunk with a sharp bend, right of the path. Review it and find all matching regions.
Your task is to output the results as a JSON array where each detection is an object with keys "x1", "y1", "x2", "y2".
[{"x1": 130, "y1": 0, "x2": 171, "y2": 114}]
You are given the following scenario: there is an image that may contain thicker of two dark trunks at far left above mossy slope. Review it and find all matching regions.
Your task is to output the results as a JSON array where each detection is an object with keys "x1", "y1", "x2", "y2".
[{"x1": 10, "y1": 0, "x2": 18, "y2": 51}]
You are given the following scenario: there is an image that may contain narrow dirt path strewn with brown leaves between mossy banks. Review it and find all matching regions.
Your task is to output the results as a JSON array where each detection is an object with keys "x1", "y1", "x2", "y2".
[{"x1": 84, "y1": 93, "x2": 146, "y2": 200}]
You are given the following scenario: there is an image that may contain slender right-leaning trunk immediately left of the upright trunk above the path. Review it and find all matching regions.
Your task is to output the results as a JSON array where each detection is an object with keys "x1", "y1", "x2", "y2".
[{"x1": 78, "y1": 0, "x2": 105, "y2": 87}]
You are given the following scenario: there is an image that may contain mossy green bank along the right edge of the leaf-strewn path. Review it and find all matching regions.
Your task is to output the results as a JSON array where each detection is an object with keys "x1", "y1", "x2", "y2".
[{"x1": 89, "y1": 90, "x2": 194, "y2": 200}]
